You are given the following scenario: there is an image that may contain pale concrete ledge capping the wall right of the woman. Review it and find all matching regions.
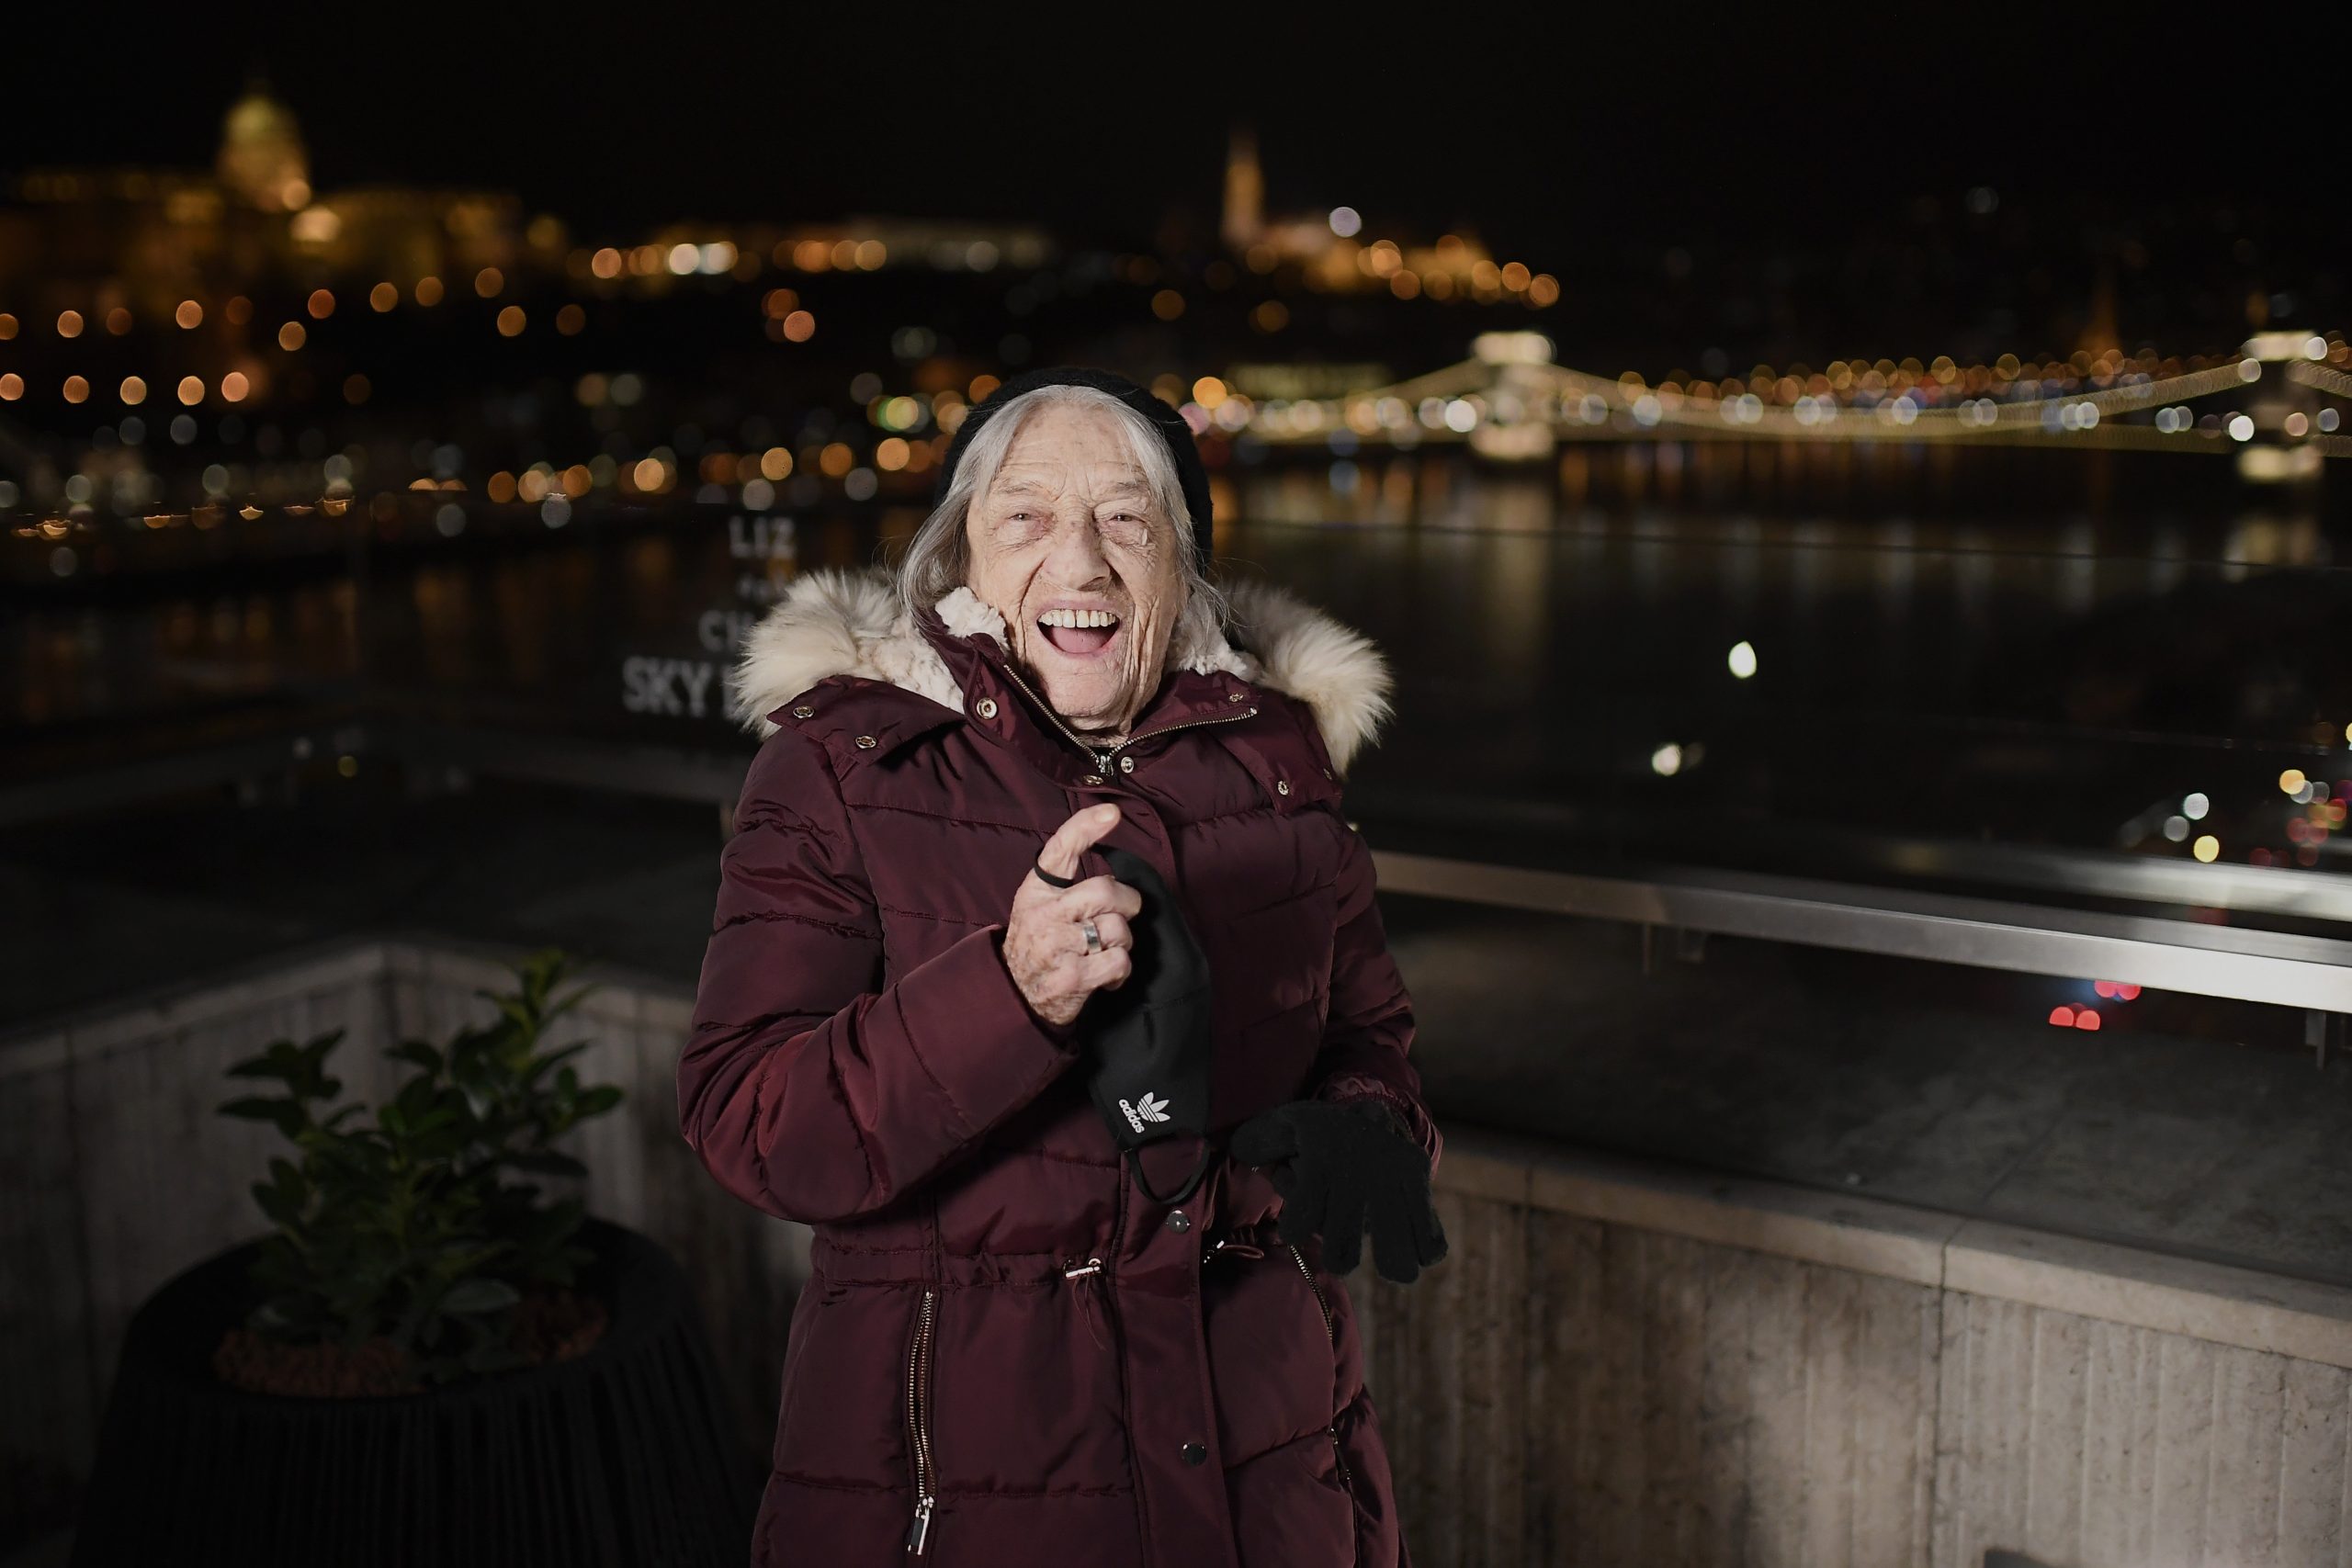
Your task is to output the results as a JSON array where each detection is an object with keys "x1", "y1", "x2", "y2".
[{"x1": 1437, "y1": 1126, "x2": 2352, "y2": 1368}]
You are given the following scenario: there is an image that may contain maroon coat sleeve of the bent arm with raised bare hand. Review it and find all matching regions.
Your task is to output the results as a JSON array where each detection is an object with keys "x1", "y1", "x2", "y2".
[{"x1": 677, "y1": 728, "x2": 1077, "y2": 1223}]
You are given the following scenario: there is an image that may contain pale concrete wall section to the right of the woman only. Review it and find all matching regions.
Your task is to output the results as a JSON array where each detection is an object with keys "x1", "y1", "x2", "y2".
[{"x1": 1350, "y1": 1128, "x2": 2352, "y2": 1568}]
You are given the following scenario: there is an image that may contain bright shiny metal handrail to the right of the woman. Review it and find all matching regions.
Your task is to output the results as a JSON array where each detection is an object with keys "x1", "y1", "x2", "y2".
[{"x1": 1374, "y1": 849, "x2": 2352, "y2": 1013}]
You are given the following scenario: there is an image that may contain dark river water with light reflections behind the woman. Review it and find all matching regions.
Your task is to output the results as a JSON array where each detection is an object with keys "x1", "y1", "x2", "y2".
[{"x1": 0, "y1": 445, "x2": 2352, "y2": 884}]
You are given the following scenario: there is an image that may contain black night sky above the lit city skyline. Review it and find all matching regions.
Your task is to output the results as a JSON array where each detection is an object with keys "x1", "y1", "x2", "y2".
[{"x1": 22, "y1": 0, "x2": 2352, "y2": 268}]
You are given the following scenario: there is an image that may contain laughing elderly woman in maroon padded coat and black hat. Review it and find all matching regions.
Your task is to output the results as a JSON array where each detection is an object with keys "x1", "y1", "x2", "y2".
[{"x1": 677, "y1": 369, "x2": 1444, "y2": 1568}]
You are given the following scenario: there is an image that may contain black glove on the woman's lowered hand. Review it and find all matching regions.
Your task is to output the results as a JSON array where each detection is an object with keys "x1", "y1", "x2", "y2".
[{"x1": 1227, "y1": 1098, "x2": 1446, "y2": 1286}]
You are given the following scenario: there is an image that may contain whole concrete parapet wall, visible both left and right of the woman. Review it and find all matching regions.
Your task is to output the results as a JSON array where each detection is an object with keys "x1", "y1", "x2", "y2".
[{"x1": 0, "y1": 941, "x2": 2352, "y2": 1568}]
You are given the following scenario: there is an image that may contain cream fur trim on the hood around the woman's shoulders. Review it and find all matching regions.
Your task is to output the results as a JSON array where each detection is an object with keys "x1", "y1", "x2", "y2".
[{"x1": 727, "y1": 567, "x2": 1393, "y2": 773}]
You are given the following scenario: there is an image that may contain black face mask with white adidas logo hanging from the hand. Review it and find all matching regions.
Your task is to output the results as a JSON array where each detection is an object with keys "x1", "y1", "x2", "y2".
[{"x1": 1080, "y1": 849, "x2": 1216, "y2": 1203}]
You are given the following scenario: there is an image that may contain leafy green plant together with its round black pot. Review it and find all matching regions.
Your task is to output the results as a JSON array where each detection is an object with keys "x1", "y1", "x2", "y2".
[{"x1": 75, "y1": 950, "x2": 757, "y2": 1568}]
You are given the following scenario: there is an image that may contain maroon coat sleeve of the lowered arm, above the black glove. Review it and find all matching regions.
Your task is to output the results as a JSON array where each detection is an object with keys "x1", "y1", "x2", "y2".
[{"x1": 1307, "y1": 808, "x2": 1444, "y2": 1170}]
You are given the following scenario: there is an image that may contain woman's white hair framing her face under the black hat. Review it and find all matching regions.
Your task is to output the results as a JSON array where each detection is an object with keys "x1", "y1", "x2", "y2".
[{"x1": 896, "y1": 386, "x2": 1232, "y2": 663}]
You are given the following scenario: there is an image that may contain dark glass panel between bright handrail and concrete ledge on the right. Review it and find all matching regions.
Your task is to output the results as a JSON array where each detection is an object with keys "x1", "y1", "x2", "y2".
[{"x1": 1381, "y1": 896, "x2": 2352, "y2": 1279}]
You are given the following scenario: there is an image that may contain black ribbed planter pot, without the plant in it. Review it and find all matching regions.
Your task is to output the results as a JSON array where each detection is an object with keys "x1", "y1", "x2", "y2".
[{"x1": 73, "y1": 1220, "x2": 760, "y2": 1568}]
